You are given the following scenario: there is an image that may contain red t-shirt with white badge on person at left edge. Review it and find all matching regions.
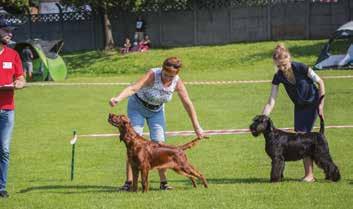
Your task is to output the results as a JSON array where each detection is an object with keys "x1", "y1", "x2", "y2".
[{"x1": 0, "y1": 46, "x2": 23, "y2": 110}]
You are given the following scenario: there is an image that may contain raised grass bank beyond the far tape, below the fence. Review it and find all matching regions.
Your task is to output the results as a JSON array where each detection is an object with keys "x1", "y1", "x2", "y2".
[{"x1": 64, "y1": 40, "x2": 353, "y2": 82}]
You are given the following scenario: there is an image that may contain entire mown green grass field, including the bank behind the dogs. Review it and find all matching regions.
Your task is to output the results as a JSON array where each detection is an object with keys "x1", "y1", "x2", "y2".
[{"x1": 0, "y1": 41, "x2": 353, "y2": 209}]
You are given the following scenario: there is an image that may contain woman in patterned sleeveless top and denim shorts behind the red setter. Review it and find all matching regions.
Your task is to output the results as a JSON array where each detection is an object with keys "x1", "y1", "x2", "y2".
[{"x1": 109, "y1": 57, "x2": 203, "y2": 191}]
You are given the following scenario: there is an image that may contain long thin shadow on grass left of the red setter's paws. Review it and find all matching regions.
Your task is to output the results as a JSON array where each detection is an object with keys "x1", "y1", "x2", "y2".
[{"x1": 18, "y1": 185, "x2": 117, "y2": 194}]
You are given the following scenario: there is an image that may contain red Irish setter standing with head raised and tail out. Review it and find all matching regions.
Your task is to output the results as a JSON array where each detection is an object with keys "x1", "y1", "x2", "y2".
[{"x1": 108, "y1": 113, "x2": 208, "y2": 192}]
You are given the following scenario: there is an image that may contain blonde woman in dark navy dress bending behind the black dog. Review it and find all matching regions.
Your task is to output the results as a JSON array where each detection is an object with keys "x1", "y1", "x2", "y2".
[{"x1": 262, "y1": 44, "x2": 325, "y2": 182}]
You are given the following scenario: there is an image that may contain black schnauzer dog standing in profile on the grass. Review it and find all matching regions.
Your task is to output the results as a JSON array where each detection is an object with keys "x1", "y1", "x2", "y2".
[{"x1": 250, "y1": 115, "x2": 341, "y2": 182}]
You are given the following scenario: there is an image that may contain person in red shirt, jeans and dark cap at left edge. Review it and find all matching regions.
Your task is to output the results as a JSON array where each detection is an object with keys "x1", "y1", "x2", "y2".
[{"x1": 0, "y1": 20, "x2": 26, "y2": 198}]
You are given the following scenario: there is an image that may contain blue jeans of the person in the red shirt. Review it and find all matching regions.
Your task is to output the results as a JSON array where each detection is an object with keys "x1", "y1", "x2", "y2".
[{"x1": 0, "y1": 110, "x2": 15, "y2": 191}]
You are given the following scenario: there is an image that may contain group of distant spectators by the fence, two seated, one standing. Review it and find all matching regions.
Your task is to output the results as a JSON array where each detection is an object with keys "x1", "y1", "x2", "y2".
[{"x1": 120, "y1": 17, "x2": 151, "y2": 54}]
